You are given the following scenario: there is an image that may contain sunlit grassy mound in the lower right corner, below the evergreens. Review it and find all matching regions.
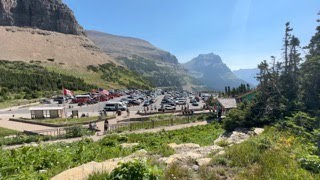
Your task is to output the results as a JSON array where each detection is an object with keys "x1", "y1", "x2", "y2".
[{"x1": 201, "y1": 127, "x2": 320, "y2": 179}]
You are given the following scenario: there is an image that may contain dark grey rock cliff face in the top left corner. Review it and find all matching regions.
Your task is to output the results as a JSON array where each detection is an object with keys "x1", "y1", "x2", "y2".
[{"x1": 0, "y1": 0, "x2": 84, "y2": 35}]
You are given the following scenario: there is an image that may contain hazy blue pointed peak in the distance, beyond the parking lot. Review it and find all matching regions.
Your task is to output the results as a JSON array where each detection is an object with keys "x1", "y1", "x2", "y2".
[{"x1": 183, "y1": 53, "x2": 246, "y2": 90}]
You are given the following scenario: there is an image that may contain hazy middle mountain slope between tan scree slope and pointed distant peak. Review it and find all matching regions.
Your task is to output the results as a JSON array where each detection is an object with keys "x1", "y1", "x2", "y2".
[{"x1": 86, "y1": 31, "x2": 198, "y2": 90}]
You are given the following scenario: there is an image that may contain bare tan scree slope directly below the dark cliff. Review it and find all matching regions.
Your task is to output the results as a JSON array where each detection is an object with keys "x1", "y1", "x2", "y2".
[{"x1": 0, "y1": 26, "x2": 113, "y2": 68}]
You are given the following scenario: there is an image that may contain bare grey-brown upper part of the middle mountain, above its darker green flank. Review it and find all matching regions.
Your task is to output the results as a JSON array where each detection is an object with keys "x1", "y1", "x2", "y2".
[{"x1": 85, "y1": 31, "x2": 178, "y2": 64}]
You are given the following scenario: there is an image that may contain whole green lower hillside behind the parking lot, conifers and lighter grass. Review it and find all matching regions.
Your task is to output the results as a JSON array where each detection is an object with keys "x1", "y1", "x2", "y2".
[{"x1": 0, "y1": 60, "x2": 152, "y2": 102}]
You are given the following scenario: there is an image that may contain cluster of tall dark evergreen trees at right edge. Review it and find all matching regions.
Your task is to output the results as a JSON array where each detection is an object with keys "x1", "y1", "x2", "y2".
[{"x1": 226, "y1": 13, "x2": 320, "y2": 130}]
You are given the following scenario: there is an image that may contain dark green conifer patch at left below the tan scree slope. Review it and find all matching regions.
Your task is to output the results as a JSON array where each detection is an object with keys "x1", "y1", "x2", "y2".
[{"x1": 0, "y1": 60, "x2": 96, "y2": 100}]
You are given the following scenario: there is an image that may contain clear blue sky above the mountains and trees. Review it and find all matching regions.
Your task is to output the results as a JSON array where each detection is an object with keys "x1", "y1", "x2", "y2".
[{"x1": 63, "y1": 0, "x2": 320, "y2": 70}]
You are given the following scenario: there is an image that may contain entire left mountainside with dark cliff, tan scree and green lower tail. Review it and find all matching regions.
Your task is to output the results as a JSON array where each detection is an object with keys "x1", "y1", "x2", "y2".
[{"x1": 0, "y1": 0, "x2": 150, "y2": 89}]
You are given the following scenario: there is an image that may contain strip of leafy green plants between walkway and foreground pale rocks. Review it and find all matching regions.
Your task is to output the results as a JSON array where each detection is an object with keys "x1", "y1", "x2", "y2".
[{"x1": 0, "y1": 124, "x2": 223, "y2": 179}]
